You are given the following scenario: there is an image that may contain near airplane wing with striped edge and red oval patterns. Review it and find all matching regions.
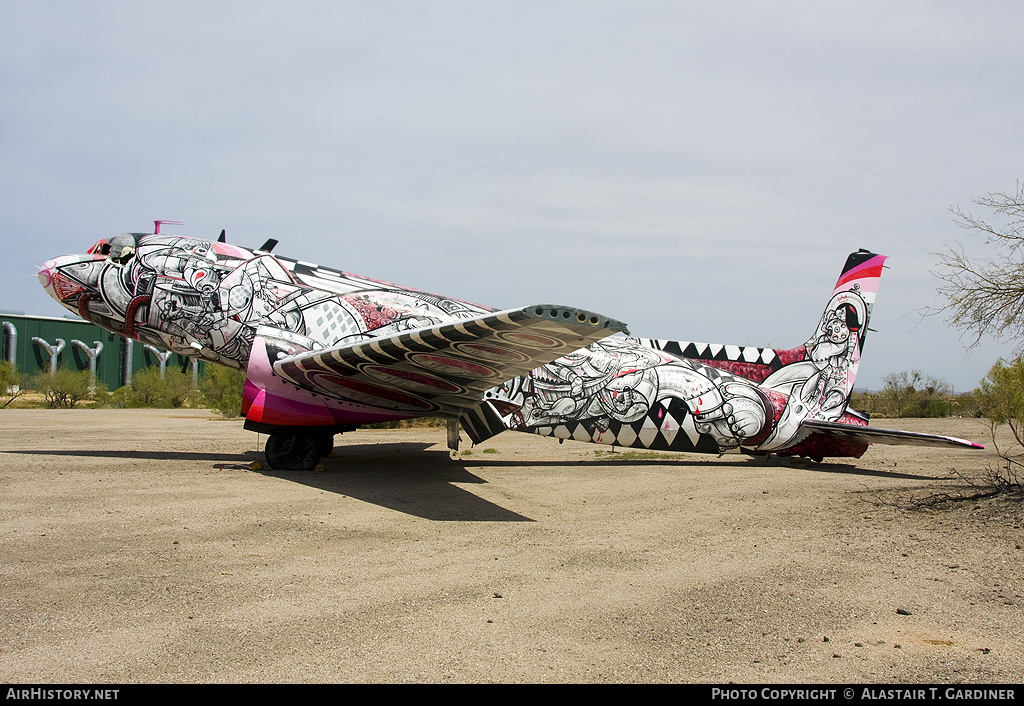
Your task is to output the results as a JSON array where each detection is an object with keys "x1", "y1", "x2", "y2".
[{"x1": 273, "y1": 304, "x2": 626, "y2": 418}]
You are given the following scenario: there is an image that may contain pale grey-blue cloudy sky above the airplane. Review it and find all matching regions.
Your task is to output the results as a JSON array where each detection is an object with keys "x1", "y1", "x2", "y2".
[{"x1": 0, "y1": 0, "x2": 1024, "y2": 391}]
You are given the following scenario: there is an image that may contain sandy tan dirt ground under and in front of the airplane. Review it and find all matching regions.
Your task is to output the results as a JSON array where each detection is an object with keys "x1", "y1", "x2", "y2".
[{"x1": 0, "y1": 410, "x2": 1024, "y2": 683}]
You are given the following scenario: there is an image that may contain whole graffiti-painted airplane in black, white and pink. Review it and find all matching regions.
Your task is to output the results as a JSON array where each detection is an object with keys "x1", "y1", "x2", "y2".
[{"x1": 39, "y1": 220, "x2": 983, "y2": 470}]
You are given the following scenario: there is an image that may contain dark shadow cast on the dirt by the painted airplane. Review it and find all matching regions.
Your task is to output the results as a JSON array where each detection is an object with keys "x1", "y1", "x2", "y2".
[{"x1": 0, "y1": 442, "x2": 936, "y2": 522}]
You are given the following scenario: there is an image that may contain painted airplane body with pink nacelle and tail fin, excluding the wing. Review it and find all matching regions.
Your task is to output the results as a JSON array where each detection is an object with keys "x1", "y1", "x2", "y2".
[{"x1": 39, "y1": 234, "x2": 885, "y2": 457}]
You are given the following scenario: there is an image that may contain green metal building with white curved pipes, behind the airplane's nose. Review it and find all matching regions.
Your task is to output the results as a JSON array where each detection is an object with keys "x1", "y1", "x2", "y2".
[{"x1": 0, "y1": 312, "x2": 203, "y2": 390}]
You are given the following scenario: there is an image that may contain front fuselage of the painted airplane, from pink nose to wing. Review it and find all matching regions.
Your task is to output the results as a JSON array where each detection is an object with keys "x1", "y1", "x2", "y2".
[{"x1": 39, "y1": 234, "x2": 494, "y2": 369}]
